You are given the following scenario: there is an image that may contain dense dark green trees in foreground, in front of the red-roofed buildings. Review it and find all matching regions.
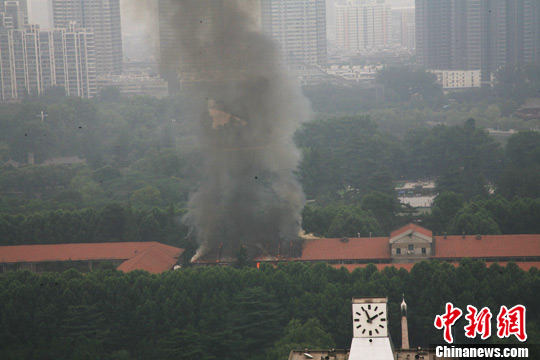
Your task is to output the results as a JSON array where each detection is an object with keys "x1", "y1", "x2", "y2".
[{"x1": 0, "y1": 260, "x2": 540, "y2": 360}]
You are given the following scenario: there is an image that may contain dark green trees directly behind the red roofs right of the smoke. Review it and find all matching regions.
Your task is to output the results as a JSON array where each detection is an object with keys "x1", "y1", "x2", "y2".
[{"x1": 302, "y1": 192, "x2": 540, "y2": 238}]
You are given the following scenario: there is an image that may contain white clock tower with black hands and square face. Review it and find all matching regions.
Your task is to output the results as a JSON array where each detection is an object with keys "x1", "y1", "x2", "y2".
[{"x1": 349, "y1": 297, "x2": 394, "y2": 360}]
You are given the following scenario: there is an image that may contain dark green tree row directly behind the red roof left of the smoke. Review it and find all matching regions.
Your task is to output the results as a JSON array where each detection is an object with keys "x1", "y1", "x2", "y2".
[{"x1": 0, "y1": 204, "x2": 194, "y2": 249}]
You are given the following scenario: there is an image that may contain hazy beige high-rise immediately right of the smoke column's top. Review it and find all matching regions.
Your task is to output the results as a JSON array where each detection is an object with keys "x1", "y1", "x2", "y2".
[{"x1": 261, "y1": 0, "x2": 328, "y2": 67}]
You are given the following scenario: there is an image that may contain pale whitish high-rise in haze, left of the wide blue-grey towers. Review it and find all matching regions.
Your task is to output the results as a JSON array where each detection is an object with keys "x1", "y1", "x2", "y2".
[{"x1": 334, "y1": 1, "x2": 392, "y2": 52}]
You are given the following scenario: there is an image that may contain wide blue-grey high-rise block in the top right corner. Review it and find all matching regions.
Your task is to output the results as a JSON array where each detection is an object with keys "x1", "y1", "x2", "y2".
[{"x1": 416, "y1": 0, "x2": 540, "y2": 83}]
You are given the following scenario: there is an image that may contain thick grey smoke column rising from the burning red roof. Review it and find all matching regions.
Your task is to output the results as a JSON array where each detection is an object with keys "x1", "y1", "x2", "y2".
[{"x1": 167, "y1": 0, "x2": 310, "y2": 259}]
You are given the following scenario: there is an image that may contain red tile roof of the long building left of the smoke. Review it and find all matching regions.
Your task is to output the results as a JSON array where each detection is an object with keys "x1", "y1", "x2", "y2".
[{"x1": 0, "y1": 242, "x2": 184, "y2": 272}]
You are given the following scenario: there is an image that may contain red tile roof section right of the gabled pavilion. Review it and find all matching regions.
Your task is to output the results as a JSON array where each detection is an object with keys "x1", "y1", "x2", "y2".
[{"x1": 433, "y1": 235, "x2": 540, "y2": 259}]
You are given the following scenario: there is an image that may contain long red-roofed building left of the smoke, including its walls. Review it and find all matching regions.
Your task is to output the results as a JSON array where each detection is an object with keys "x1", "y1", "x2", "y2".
[{"x1": 0, "y1": 242, "x2": 184, "y2": 273}]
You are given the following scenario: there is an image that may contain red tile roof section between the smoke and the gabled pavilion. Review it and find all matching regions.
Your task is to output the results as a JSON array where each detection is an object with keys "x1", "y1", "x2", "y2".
[{"x1": 298, "y1": 237, "x2": 390, "y2": 261}]
